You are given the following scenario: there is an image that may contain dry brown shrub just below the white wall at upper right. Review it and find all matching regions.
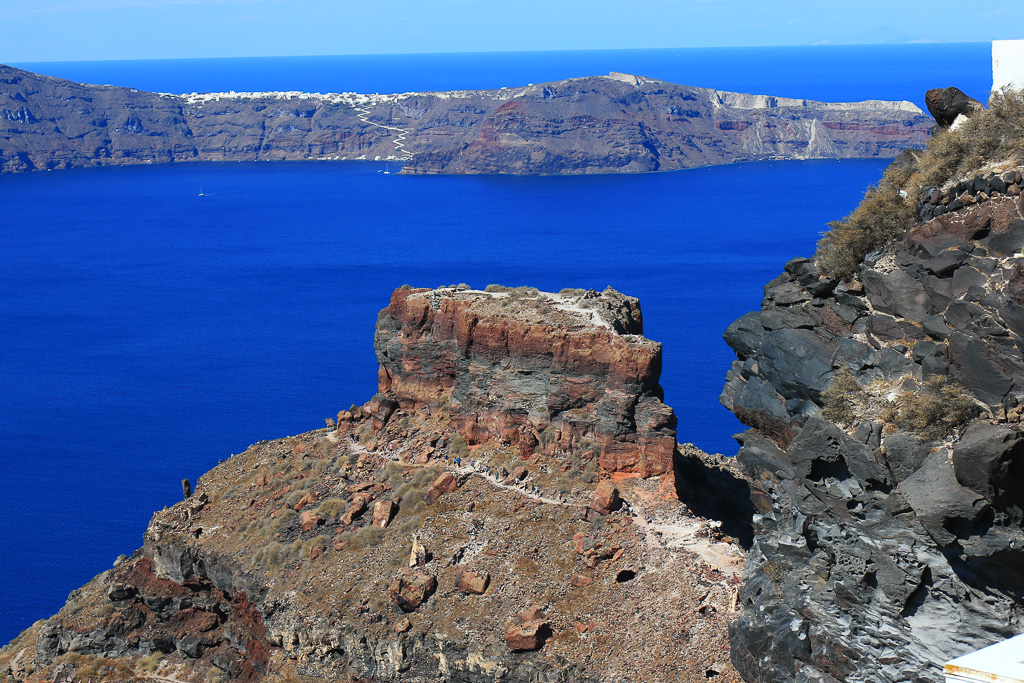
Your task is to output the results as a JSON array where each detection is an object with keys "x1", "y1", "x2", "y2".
[{"x1": 920, "y1": 88, "x2": 1024, "y2": 185}]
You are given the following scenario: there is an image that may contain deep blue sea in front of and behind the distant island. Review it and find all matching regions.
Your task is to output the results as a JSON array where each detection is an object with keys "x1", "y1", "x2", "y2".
[{"x1": 0, "y1": 43, "x2": 991, "y2": 642}]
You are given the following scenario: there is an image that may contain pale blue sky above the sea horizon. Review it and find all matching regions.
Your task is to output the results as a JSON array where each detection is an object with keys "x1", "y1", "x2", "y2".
[{"x1": 0, "y1": 0, "x2": 1024, "y2": 62}]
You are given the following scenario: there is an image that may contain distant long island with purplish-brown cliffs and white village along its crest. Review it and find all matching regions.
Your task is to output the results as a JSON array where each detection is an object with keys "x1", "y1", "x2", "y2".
[{"x1": 0, "y1": 66, "x2": 933, "y2": 174}]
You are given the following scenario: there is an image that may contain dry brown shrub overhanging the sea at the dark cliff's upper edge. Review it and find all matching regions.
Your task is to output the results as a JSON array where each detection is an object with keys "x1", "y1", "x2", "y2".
[{"x1": 814, "y1": 166, "x2": 914, "y2": 278}]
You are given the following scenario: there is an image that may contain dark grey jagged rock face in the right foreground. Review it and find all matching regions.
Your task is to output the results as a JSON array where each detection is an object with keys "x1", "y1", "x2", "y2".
[{"x1": 722, "y1": 197, "x2": 1024, "y2": 682}]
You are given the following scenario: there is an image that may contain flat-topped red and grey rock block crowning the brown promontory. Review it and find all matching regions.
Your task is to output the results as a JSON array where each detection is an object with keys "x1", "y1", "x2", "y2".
[{"x1": 374, "y1": 289, "x2": 676, "y2": 477}]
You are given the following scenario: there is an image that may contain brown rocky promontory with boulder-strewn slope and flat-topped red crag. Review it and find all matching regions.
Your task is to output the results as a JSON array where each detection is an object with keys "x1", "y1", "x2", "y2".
[{"x1": 0, "y1": 288, "x2": 744, "y2": 683}]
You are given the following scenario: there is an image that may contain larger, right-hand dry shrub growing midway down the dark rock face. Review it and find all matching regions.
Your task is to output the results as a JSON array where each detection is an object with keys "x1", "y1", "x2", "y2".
[{"x1": 883, "y1": 376, "x2": 976, "y2": 439}]
